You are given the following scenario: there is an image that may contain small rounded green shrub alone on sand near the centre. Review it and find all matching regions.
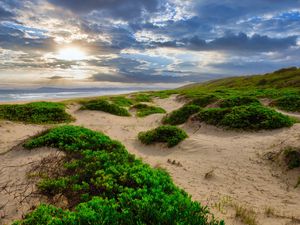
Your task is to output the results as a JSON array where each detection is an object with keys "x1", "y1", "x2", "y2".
[{"x1": 138, "y1": 125, "x2": 188, "y2": 147}]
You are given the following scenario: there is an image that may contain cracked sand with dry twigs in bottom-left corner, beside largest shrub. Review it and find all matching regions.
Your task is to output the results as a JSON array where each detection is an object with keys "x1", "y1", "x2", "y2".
[{"x1": 0, "y1": 147, "x2": 58, "y2": 225}]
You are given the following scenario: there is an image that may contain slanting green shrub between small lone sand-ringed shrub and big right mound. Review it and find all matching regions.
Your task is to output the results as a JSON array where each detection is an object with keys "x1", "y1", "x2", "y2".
[{"x1": 162, "y1": 105, "x2": 201, "y2": 125}]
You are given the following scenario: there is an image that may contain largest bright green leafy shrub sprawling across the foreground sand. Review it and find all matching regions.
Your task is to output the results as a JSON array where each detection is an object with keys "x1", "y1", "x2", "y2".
[{"x1": 15, "y1": 126, "x2": 220, "y2": 225}]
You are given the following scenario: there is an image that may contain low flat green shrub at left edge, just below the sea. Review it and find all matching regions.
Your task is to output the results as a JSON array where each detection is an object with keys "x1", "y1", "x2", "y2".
[{"x1": 0, "y1": 102, "x2": 73, "y2": 124}]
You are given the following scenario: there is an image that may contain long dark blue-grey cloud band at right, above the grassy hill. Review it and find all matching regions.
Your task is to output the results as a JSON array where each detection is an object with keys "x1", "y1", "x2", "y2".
[{"x1": 152, "y1": 33, "x2": 297, "y2": 52}]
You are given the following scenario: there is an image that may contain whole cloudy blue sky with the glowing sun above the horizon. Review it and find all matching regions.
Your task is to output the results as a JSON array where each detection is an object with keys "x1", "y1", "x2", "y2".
[{"x1": 0, "y1": 0, "x2": 300, "y2": 88}]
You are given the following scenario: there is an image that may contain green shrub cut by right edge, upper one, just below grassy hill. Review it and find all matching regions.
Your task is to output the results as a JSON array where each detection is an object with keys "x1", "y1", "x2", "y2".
[{"x1": 271, "y1": 95, "x2": 300, "y2": 112}]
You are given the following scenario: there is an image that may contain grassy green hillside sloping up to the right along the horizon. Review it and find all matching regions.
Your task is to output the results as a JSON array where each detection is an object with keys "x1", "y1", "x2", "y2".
[{"x1": 148, "y1": 67, "x2": 300, "y2": 99}]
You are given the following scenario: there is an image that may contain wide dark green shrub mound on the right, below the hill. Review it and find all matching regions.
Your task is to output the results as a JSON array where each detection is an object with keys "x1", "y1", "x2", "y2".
[{"x1": 195, "y1": 104, "x2": 294, "y2": 130}]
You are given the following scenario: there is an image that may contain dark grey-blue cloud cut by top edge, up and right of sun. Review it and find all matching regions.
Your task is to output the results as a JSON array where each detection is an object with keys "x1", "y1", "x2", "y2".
[{"x1": 49, "y1": 0, "x2": 159, "y2": 20}]
